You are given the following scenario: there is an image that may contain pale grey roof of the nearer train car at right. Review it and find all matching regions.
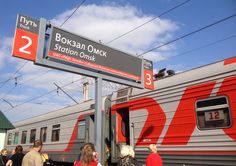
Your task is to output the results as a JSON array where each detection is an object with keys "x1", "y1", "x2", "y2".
[{"x1": 112, "y1": 56, "x2": 236, "y2": 101}]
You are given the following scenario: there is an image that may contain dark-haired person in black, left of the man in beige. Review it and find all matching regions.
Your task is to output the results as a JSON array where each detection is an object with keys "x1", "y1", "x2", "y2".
[{"x1": 6, "y1": 145, "x2": 24, "y2": 166}]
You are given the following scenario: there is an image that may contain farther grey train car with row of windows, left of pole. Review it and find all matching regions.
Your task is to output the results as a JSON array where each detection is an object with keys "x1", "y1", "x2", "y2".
[{"x1": 5, "y1": 100, "x2": 110, "y2": 165}]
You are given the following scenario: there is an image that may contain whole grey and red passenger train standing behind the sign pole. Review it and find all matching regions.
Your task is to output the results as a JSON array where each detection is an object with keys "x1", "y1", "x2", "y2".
[{"x1": 3, "y1": 57, "x2": 236, "y2": 165}]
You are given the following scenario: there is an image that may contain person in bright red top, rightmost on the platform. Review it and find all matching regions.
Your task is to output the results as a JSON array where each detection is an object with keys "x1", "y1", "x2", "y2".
[{"x1": 146, "y1": 144, "x2": 162, "y2": 166}]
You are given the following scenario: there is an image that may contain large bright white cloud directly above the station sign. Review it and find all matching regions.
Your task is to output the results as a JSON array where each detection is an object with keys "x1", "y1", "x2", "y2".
[{"x1": 52, "y1": 4, "x2": 179, "y2": 60}]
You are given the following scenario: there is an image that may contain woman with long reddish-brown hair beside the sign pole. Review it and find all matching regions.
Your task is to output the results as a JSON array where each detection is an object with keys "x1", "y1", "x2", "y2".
[{"x1": 74, "y1": 143, "x2": 100, "y2": 166}]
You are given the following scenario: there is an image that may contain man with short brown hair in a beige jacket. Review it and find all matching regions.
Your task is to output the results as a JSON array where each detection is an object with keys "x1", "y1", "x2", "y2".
[{"x1": 22, "y1": 140, "x2": 43, "y2": 166}]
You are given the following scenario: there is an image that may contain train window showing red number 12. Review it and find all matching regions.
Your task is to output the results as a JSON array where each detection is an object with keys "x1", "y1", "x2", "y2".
[{"x1": 196, "y1": 96, "x2": 231, "y2": 129}]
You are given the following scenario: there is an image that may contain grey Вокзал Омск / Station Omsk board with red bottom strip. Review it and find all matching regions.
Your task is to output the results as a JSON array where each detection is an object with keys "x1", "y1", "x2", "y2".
[{"x1": 47, "y1": 27, "x2": 142, "y2": 82}]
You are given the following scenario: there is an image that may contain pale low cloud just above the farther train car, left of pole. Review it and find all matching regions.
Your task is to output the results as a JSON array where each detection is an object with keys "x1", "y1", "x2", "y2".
[{"x1": 1, "y1": 87, "x2": 81, "y2": 121}]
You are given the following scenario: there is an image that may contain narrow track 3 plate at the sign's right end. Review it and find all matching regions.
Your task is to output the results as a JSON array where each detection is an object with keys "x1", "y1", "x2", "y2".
[{"x1": 143, "y1": 59, "x2": 154, "y2": 90}]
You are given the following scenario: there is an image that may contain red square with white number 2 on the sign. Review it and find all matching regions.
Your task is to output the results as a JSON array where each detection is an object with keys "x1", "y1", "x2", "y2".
[{"x1": 12, "y1": 28, "x2": 38, "y2": 61}]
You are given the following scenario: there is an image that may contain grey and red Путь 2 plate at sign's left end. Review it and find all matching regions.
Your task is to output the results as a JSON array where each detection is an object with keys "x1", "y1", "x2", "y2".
[{"x1": 12, "y1": 14, "x2": 39, "y2": 61}]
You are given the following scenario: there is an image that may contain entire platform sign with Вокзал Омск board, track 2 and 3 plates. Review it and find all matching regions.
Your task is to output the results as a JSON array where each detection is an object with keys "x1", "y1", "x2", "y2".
[{"x1": 12, "y1": 14, "x2": 151, "y2": 89}]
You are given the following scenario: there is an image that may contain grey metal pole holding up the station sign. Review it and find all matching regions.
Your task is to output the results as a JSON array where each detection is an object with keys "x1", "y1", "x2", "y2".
[{"x1": 94, "y1": 77, "x2": 103, "y2": 163}]
